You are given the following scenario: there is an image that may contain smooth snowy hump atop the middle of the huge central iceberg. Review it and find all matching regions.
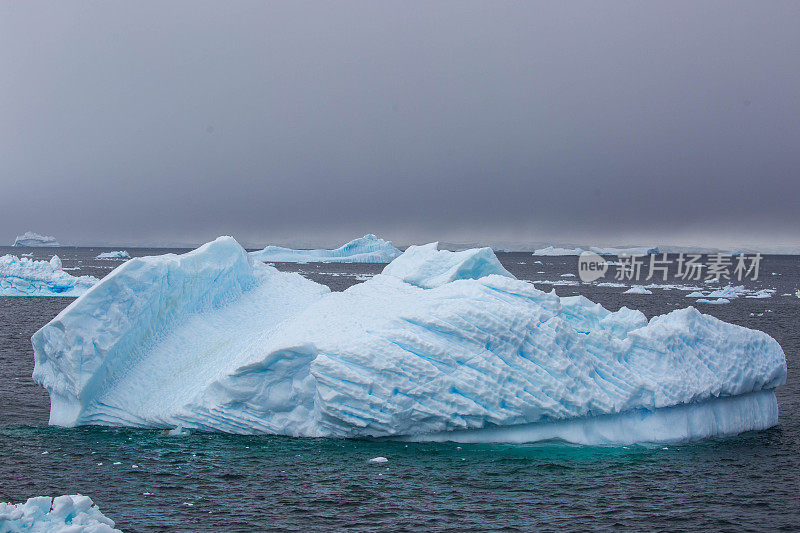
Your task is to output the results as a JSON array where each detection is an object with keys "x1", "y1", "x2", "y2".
[{"x1": 383, "y1": 242, "x2": 513, "y2": 289}]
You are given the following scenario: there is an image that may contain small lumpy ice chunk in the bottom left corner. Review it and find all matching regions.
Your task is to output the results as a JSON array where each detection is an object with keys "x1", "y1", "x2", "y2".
[{"x1": 0, "y1": 494, "x2": 119, "y2": 533}]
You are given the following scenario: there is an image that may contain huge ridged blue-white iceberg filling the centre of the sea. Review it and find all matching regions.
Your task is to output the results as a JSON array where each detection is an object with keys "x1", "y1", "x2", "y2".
[{"x1": 32, "y1": 237, "x2": 786, "y2": 444}]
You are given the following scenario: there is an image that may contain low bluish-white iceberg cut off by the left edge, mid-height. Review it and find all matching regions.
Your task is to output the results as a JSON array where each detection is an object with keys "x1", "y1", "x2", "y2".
[{"x1": 0, "y1": 255, "x2": 99, "y2": 297}]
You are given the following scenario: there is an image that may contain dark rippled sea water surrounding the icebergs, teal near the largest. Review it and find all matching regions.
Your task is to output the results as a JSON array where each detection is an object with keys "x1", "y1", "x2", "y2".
[{"x1": 0, "y1": 247, "x2": 800, "y2": 531}]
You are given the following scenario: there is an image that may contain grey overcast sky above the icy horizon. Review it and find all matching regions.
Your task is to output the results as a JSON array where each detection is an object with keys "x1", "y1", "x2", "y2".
[{"x1": 0, "y1": 0, "x2": 800, "y2": 246}]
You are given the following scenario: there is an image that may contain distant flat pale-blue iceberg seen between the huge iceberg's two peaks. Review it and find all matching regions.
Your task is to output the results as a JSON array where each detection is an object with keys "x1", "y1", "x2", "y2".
[{"x1": 250, "y1": 234, "x2": 402, "y2": 263}]
